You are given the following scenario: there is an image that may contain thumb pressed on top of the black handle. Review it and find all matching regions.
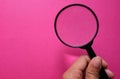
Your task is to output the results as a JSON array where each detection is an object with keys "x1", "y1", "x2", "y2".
[{"x1": 85, "y1": 56, "x2": 102, "y2": 79}]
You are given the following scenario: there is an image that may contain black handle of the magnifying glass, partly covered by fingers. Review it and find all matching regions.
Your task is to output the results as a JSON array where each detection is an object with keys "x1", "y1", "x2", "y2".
[{"x1": 86, "y1": 46, "x2": 110, "y2": 79}]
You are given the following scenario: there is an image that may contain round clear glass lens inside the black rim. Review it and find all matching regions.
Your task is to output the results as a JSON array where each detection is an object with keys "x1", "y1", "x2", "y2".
[{"x1": 56, "y1": 6, "x2": 97, "y2": 47}]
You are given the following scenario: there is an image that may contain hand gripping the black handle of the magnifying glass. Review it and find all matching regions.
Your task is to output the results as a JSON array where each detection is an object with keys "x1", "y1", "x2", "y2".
[{"x1": 63, "y1": 55, "x2": 114, "y2": 79}]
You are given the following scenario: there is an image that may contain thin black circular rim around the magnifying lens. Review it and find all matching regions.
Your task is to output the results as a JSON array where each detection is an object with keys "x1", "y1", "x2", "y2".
[{"x1": 54, "y1": 4, "x2": 99, "y2": 48}]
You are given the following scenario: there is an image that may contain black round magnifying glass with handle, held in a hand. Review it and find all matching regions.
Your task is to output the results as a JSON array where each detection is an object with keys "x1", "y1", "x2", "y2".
[{"x1": 54, "y1": 4, "x2": 109, "y2": 79}]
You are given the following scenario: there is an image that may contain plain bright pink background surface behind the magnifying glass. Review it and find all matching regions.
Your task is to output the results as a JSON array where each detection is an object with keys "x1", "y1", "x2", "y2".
[{"x1": 0, "y1": 0, "x2": 120, "y2": 79}]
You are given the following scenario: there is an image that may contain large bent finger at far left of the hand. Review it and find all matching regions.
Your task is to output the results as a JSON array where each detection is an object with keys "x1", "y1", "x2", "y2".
[{"x1": 63, "y1": 55, "x2": 90, "y2": 79}]
